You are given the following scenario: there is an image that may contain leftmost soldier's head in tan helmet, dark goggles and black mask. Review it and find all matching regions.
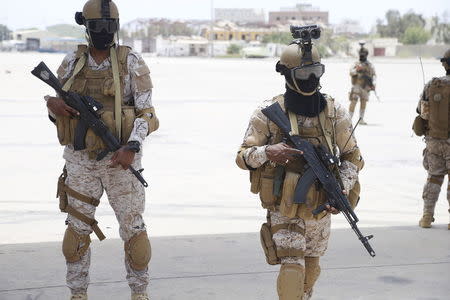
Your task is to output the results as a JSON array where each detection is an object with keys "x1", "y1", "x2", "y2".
[{"x1": 75, "y1": 0, "x2": 119, "y2": 49}]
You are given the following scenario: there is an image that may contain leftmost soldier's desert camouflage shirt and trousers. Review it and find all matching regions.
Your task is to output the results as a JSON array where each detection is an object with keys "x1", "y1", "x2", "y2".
[{"x1": 55, "y1": 51, "x2": 153, "y2": 294}]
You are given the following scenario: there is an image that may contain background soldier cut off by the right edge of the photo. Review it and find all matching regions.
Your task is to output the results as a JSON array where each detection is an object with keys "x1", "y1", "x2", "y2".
[{"x1": 413, "y1": 49, "x2": 450, "y2": 230}]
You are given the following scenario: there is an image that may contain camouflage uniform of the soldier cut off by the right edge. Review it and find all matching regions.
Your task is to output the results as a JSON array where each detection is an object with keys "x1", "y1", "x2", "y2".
[{"x1": 417, "y1": 75, "x2": 450, "y2": 228}]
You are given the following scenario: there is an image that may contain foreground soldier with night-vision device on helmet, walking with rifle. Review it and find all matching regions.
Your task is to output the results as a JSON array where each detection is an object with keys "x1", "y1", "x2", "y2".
[{"x1": 236, "y1": 37, "x2": 363, "y2": 300}]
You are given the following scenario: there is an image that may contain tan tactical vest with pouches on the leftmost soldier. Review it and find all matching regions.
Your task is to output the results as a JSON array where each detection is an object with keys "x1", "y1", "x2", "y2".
[{"x1": 56, "y1": 45, "x2": 136, "y2": 153}]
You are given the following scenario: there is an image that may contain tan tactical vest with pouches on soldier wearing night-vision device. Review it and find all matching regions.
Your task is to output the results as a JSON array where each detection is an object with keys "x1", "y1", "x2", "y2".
[{"x1": 250, "y1": 96, "x2": 360, "y2": 220}]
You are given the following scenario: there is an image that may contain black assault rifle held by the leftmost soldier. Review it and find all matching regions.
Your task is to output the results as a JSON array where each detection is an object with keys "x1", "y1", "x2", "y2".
[{"x1": 31, "y1": 62, "x2": 148, "y2": 187}]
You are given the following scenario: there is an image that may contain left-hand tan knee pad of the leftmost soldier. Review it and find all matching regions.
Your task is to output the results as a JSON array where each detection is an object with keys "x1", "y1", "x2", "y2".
[{"x1": 62, "y1": 226, "x2": 91, "y2": 263}]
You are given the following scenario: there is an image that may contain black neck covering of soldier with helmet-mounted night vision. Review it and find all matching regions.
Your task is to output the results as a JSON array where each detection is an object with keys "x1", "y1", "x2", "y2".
[{"x1": 284, "y1": 87, "x2": 327, "y2": 118}]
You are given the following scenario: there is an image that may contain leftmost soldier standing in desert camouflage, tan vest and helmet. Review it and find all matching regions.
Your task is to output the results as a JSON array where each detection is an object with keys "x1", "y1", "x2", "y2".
[{"x1": 46, "y1": 0, "x2": 159, "y2": 300}]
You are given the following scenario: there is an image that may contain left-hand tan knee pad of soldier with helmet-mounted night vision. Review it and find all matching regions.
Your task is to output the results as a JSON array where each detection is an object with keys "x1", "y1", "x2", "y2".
[{"x1": 277, "y1": 264, "x2": 305, "y2": 300}]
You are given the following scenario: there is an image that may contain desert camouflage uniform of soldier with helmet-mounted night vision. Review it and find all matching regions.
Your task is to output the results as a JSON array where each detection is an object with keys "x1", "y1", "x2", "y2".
[{"x1": 237, "y1": 96, "x2": 362, "y2": 299}]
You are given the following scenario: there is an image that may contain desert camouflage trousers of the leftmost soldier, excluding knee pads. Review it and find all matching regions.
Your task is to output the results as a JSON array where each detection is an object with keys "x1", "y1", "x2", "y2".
[{"x1": 64, "y1": 147, "x2": 149, "y2": 294}]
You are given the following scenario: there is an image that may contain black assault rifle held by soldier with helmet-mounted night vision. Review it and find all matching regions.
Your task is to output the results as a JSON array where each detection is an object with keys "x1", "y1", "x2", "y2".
[{"x1": 262, "y1": 102, "x2": 375, "y2": 257}]
